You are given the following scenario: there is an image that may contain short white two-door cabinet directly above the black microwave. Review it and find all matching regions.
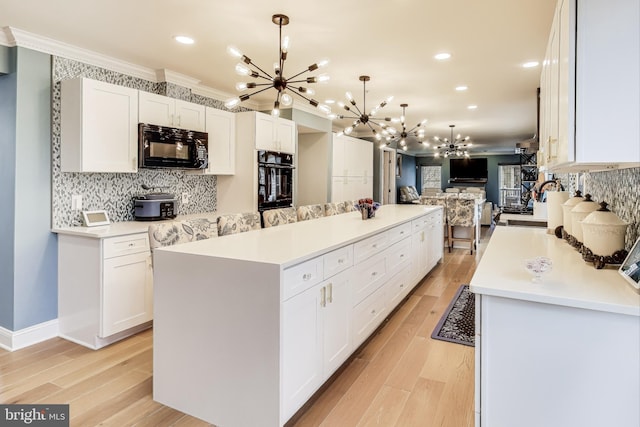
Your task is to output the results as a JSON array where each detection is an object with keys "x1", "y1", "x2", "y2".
[{"x1": 139, "y1": 91, "x2": 205, "y2": 132}]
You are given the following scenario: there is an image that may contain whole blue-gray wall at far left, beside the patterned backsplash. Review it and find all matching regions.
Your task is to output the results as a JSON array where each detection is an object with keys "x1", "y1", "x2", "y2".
[{"x1": 0, "y1": 48, "x2": 58, "y2": 330}]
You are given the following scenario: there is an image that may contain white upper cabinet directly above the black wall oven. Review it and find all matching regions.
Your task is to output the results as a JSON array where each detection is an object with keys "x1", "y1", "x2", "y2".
[{"x1": 254, "y1": 112, "x2": 296, "y2": 154}]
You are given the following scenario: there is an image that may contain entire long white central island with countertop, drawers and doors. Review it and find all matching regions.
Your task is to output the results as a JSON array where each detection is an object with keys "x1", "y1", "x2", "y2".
[{"x1": 153, "y1": 205, "x2": 443, "y2": 427}]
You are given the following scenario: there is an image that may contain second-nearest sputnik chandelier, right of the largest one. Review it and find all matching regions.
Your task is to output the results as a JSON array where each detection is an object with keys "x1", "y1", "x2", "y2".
[{"x1": 334, "y1": 76, "x2": 397, "y2": 141}]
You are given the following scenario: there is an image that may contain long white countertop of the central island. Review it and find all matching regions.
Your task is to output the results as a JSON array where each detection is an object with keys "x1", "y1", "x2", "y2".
[{"x1": 156, "y1": 204, "x2": 442, "y2": 267}]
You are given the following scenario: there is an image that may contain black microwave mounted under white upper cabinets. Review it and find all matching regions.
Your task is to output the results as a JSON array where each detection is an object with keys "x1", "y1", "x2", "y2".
[{"x1": 138, "y1": 123, "x2": 209, "y2": 169}]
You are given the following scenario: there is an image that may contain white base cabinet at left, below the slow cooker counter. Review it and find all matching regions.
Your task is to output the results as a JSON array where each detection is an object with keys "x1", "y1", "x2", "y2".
[{"x1": 58, "y1": 233, "x2": 153, "y2": 349}]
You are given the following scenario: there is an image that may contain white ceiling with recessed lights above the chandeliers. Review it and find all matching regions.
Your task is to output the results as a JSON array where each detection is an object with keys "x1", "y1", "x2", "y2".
[{"x1": 0, "y1": 0, "x2": 555, "y2": 154}]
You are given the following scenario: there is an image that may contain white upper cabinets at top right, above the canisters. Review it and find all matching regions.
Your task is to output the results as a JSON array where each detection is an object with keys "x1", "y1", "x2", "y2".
[{"x1": 538, "y1": 0, "x2": 640, "y2": 171}]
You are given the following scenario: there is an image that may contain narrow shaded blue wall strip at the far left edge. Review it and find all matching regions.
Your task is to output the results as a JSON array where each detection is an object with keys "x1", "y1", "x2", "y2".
[{"x1": 0, "y1": 46, "x2": 17, "y2": 329}]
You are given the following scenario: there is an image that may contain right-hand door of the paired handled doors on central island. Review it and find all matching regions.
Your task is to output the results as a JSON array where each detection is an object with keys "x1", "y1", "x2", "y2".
[{"x1": 320, "y1": 272, "x2": 352, "y2": 378}]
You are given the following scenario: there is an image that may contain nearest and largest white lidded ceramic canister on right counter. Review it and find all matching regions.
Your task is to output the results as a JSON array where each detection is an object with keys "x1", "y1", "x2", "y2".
[{"x1": 581, "y1": 202, "x2": 629, "y2": 256}]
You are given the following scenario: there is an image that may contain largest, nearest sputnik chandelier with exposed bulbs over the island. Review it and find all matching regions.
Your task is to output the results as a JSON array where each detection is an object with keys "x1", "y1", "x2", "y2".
[{"x1": 224, "y1": 14, "x2": 331, "y2": 116}]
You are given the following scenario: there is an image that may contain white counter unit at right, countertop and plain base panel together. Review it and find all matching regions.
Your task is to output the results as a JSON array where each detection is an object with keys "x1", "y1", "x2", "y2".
[{"x1": 470, "y1": 227, "x2": 640, "y2": 427}]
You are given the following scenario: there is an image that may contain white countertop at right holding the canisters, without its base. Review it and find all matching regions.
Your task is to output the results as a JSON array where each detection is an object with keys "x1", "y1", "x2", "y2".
[{"x1": 470, "y1": 227, "x2": 640, "y2": 316}]
